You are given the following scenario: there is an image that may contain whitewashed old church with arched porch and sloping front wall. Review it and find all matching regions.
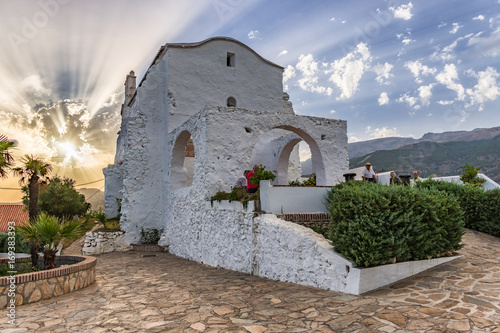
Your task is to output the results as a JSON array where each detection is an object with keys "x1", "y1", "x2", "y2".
[{"x1": 104, "y1": 37, "x2": 454, "y2": 294}]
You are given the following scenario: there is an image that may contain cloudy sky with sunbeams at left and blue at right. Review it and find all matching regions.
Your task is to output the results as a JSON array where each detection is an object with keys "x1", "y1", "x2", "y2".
[{"x1": 0, "y1": 0, "x2": 500, "y2": 202}]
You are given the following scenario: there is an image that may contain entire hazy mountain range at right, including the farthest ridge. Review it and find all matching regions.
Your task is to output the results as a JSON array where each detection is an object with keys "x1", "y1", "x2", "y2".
[{"x1": 348, "y1": 127, "x2": 500, "y2": 182}]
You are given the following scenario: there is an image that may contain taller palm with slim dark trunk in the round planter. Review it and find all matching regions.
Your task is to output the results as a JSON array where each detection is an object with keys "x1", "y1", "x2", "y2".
[{"x1": 12, "y1": 155, "x2": 52, "y2": 268}]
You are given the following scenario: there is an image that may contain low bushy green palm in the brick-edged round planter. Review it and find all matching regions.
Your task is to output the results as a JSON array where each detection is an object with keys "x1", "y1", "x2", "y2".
[{"x1": 19, "y1": 213, "x2": 80, "y2": 269}]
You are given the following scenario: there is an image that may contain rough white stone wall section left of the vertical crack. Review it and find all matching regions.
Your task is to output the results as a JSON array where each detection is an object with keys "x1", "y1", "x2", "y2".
[{"x1": 166, "y1": 188, "x2": 253, "y2": 273}]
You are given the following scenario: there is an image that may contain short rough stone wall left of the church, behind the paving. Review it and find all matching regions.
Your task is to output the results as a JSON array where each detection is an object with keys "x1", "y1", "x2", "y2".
[{"x1": 82, "y1": 231, "x2": 131, "y2": 256}]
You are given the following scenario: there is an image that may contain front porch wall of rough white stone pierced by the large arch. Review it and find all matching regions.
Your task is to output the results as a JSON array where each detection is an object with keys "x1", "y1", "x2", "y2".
[{"x1": 199, "y1": 108, "x2": 348, "y2": 189}]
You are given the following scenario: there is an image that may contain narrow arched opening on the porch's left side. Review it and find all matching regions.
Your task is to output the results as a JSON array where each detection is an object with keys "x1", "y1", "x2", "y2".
[{"x1": 170, "y1": 130, "x2": 196, "y2": 190}]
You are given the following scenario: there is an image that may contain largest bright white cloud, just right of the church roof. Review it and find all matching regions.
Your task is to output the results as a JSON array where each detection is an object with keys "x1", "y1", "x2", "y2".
[{"x1": 325, "y1": 43, "x2": 371, "y2": 100}]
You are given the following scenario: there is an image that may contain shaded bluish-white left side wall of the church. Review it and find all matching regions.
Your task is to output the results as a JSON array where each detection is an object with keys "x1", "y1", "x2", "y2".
[{"x1": 120, "y1": 62, "x2": 167, "y2": 244}]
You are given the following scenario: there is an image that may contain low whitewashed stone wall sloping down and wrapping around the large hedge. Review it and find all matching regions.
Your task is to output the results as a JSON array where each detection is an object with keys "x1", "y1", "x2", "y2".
[{"x1": 166, "y1": 197, "x2": 457, "y2": 295}]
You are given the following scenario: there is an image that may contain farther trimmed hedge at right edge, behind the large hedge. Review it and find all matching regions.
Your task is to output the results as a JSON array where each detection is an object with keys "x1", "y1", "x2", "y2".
[{"x1": 415, "y1": 179, "x2": 500, "y2": 237}]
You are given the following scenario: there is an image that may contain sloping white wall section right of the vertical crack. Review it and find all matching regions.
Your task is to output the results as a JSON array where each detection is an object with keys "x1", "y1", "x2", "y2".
[{"x1": 254, "y1": 214, "x2": 356, "y2": 293}]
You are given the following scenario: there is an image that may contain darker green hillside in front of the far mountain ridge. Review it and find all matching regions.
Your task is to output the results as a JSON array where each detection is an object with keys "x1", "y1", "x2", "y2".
[{"x1": 350, "y1": 134, "x2": 500, "y2": 182}]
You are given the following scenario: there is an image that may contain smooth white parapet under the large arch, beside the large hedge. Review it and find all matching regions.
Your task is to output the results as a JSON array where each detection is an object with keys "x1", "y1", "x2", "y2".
[{"x1": 260, "y1": 180, "x2": 331, "y2": 214}]
